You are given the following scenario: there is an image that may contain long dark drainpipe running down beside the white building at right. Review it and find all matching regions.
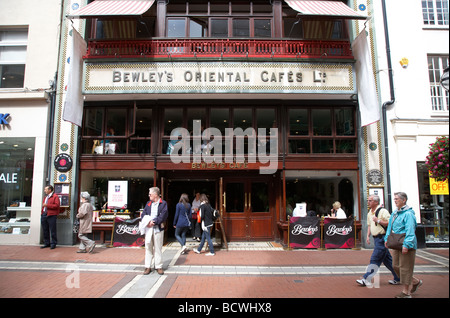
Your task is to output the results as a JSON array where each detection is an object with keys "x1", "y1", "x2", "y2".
[{"x1": 381, "y1": 0, "x2": 395, "y2": 211}]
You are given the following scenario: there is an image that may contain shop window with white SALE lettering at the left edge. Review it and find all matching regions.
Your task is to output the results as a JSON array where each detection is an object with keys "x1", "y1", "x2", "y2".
[{"x1": 0, "y1": 138, "x2": 35, "y2": 234}]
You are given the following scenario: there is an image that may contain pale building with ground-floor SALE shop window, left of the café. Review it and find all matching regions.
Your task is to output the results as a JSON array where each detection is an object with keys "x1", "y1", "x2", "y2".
[{"x1": 0, "y1": 0, "x2": 61, "y2": 244}]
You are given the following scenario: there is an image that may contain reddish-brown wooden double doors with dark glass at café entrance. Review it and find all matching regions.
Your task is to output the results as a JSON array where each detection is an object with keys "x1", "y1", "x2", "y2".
[{"x1": 221, "y1": 178, "x2": 274, "y2": 241}]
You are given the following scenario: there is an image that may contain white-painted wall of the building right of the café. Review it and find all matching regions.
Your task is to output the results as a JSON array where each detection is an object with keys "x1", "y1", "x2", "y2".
[{"x1": 374, "y1": 0, "x2": 449, "y2": 216}]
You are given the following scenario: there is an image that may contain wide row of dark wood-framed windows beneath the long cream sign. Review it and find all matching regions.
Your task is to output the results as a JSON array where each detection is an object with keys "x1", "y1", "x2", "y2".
[{"x1": 82, "y1": 102, "x2": 357, "y2": 155}]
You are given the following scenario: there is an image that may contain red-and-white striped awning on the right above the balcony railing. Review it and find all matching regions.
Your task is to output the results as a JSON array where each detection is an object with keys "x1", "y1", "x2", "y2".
[{"x1": 284, "y1": 0, "x2": 367, "y2": 20}]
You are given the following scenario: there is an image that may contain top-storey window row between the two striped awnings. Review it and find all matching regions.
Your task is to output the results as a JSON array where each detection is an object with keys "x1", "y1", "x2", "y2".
[{"x1": 166, "y1": 0, "x2": 273, "y2": 38}]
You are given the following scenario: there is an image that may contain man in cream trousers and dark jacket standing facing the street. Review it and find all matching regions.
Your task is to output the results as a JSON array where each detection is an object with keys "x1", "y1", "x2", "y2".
[{"x1": 141, "y1": 187, "x2": 168, "y2": 275}]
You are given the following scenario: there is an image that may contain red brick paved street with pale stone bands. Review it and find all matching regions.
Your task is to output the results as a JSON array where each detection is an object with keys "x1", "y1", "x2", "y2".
[{"x1": 0, "y1": 243, "x2": 449, "y2": 312}]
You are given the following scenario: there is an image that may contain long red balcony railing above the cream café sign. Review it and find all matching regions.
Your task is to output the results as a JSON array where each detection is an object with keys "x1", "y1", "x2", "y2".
[{"x1": 84, "y1": 39, "x2": 353, "y2": 59}]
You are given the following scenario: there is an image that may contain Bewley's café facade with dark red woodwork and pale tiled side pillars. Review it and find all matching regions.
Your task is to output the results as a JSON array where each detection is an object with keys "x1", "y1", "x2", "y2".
[{"x1": 43, "y1": 0, "x2": 385, "y2": 244}]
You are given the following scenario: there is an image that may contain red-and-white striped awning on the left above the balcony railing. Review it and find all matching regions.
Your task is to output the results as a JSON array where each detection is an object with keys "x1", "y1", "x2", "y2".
[{"x1": 67, "y1": 0, "x2": 155, "y2": 19}]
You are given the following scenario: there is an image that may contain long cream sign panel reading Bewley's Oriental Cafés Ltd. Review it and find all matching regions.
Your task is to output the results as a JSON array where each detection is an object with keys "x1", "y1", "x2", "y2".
[{"x1": 83, "y1": 62, "x2": 356, "y2": 95}]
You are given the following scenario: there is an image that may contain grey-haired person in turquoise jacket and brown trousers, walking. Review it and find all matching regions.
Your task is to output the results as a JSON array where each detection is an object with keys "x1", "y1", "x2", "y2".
[{"x1": 384, "y1": 192, "x2": 423, "y2": 298}]
